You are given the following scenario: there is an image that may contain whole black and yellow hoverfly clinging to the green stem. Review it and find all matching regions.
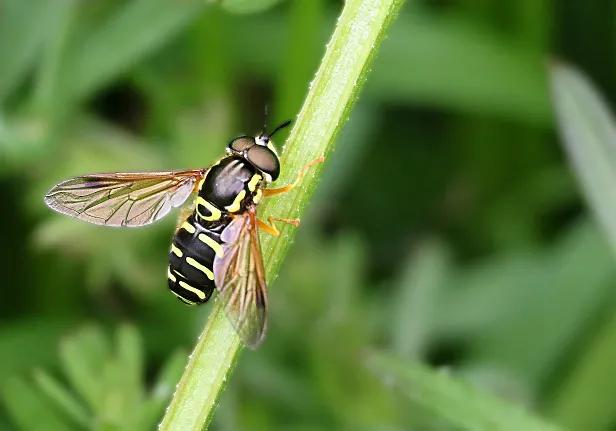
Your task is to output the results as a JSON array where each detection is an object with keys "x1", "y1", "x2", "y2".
[{"x1": 45, "y1": 121, "x2": 324, "y2": 349}]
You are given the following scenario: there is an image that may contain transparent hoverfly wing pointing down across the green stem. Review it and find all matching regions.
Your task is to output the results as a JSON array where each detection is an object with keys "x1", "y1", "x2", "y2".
[{"x1": 214, "y1": 210, "x2": 267, "y2": 349}]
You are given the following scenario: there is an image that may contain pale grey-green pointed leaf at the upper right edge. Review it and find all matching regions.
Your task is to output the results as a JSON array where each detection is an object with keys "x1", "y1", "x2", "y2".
[{"x1": 550, "y1": 63, "x2": 616, "y2": 253}]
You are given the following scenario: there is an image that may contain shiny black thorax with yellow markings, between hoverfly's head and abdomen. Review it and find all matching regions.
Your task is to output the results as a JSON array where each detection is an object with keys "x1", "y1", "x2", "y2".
[{"x1": 196, "y1": 156, "x2": 262, "y2": 222}]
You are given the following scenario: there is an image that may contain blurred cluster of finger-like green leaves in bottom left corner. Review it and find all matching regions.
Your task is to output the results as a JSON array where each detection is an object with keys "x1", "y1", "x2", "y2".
[{"x1": 2, "y1": 326, "x2": 187, "y2": 431}]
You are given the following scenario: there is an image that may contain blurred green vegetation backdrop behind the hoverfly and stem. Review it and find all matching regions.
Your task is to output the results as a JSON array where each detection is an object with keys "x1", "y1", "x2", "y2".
[{"x1": 0, "y1": 0, "x2": 616, "y2": 430}]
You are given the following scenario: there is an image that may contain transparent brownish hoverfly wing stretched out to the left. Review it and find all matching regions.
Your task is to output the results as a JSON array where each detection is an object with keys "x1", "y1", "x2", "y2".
[{"x1": 45, "y1": 169, "x2": 206, "y2": 227}]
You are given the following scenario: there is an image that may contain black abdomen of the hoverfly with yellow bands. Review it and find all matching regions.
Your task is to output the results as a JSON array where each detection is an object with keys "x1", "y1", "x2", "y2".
[{"x1": 167, "y1": 213, "x2": 226, "y2": 305}]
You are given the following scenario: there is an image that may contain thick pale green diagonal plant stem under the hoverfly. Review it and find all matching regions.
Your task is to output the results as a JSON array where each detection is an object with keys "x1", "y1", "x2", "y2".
[{"x1": 160, "y1": 0, "x2": 404, "y2": 431}]
